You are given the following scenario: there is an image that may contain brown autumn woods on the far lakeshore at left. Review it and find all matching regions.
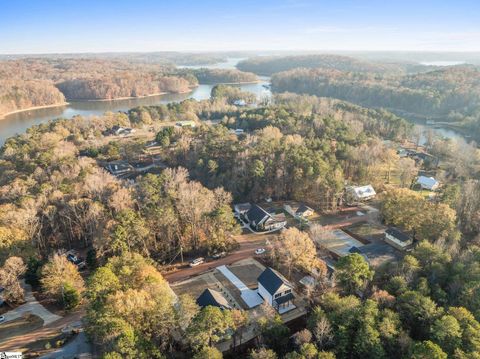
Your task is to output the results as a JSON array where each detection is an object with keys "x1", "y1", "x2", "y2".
[{"x1": 0, "y1": 58, "x2": 198, "y2": 116}]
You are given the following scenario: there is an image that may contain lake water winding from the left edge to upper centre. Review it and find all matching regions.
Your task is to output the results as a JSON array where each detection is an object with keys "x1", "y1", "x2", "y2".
[{"x1": 0, "y1": 59, "x2": 272, "y2": 146}]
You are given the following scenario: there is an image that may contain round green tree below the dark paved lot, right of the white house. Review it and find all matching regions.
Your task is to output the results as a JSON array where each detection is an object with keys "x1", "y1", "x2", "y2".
[{"x1": 336, "y1": 253, "x2": 374, "y2": 294}]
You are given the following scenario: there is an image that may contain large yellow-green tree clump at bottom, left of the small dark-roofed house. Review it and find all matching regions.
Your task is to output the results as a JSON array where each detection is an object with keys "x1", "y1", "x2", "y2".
[{"x1": 87, "y1": 252, "x2": 179, "y2": 358}]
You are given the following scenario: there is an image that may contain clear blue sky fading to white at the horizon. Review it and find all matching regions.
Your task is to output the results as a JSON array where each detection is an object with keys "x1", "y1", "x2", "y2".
[{"x1": 0, "y1": 0, "x2": 480, "y2": 54}]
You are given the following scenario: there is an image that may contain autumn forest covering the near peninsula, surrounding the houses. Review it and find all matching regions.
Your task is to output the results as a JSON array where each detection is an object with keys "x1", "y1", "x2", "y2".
[{"x1": 0, "y1": 85, "x2": 480, "y2": 359}]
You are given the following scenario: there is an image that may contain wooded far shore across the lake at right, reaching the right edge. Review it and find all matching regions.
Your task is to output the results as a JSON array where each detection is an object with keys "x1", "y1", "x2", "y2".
[{"x1": 272, "y1": 66, "x2": 480, "y2": 135}]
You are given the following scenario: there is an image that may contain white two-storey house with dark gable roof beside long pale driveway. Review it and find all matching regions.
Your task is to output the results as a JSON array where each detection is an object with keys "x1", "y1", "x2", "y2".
[{"x1": 258, "y1": 268, "x2": 295, "y2": 314}]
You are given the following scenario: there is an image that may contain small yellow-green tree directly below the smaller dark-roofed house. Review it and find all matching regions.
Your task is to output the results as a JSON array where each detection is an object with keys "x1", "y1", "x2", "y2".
[{"x1": 187, "y1": 306, "x2": 233, "y2": 348}]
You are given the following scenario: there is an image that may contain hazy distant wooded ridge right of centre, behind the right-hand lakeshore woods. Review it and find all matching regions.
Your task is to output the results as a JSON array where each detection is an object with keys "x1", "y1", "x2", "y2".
[{"x1": 237, "y1": 55, "x2": 412, "y2": 75}]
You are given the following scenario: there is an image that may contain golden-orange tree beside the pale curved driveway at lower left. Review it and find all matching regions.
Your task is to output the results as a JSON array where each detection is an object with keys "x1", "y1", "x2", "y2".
[{"x1": 40, "y1": 254, "x2": 84, "y2": 306}]
